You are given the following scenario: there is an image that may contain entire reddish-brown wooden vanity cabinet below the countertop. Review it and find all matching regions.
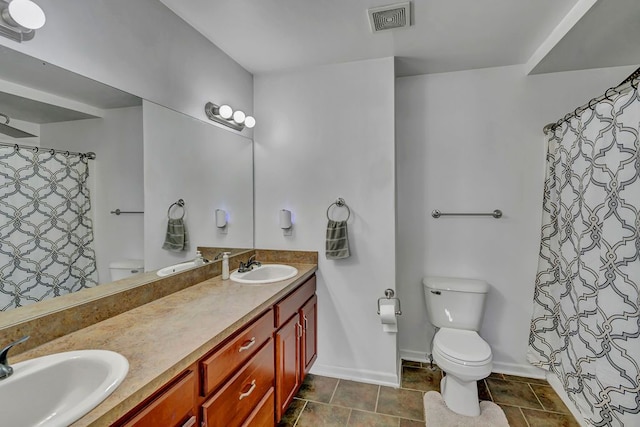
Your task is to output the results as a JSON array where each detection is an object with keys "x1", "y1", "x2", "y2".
[{"x1": 114, "y1": 275, "x2": 318, "y2": 427}]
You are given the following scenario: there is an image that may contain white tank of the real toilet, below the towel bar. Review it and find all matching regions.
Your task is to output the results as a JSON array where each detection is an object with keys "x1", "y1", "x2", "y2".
[{"x1": 422, "y1": 276, "x2": 489, "y2": 331}]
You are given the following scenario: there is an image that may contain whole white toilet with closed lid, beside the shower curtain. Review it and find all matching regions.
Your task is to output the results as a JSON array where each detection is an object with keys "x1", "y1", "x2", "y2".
[{"x1": 422, "y1": 277, "x2": 492, "y2": 417}]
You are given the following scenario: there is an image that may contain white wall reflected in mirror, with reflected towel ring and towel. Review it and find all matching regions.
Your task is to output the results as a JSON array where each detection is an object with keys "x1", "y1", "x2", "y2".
[{"x1": 143, "y1": 101, "x2": 253, "y2": 271}]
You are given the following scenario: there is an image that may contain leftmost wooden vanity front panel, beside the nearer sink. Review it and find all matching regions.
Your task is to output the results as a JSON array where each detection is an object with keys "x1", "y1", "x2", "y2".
[{"x1": 123, "y1": 371, "x2": 196, "y2": 427}]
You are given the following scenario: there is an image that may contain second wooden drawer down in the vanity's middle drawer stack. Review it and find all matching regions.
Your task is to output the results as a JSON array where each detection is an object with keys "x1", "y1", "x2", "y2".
[{"x1": 202, "y1": 339, "x2": 274, "y2": 427}]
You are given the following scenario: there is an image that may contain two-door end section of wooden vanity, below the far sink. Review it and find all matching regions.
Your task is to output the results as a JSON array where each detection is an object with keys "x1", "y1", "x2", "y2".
[{"x1": 275, "y1": 276, "x2": 317, "y2": 422}]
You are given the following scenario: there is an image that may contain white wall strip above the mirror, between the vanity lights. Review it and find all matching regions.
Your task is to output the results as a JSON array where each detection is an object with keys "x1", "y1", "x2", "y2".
[{"x1": 0, "y1": 0, "x2": 253, "y2": 130}]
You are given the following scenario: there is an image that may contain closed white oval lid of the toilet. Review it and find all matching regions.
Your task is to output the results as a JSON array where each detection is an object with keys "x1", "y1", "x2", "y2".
[{"x1": 433, "y1": 328, "x2": 491, "y2": 363}]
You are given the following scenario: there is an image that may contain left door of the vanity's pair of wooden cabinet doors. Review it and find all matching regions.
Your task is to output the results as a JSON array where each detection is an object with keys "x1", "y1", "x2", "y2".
[{"x1": 276, "y1": 316, "x2": 302, "y2": 421}]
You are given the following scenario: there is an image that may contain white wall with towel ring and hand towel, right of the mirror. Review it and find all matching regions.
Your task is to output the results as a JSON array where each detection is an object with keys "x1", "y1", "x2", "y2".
[{"x1": 254, "y1": 58, "x2": 398, "y2": 383}]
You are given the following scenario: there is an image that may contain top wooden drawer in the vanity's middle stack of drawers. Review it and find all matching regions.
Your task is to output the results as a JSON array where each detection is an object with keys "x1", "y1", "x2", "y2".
[{"x1": 200, "y1": 310, "x2": 273, "y2": 396}]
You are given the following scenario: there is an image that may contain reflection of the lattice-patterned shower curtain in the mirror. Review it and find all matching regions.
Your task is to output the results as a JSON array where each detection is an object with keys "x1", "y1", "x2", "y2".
[{"x1": 0, "y1": 147, "x2": 97, "y2": 310}]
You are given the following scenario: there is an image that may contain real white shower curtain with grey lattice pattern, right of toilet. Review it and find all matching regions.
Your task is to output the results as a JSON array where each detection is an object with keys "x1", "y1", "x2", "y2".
[{"x1": 528, "y1": 81, "x2": 640, "y2": 427}]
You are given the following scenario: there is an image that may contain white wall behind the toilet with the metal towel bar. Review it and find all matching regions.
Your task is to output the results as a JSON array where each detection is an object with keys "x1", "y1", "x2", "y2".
[{"x1": 396, "y1": 62, "x2": 634, "y2": 374}]
